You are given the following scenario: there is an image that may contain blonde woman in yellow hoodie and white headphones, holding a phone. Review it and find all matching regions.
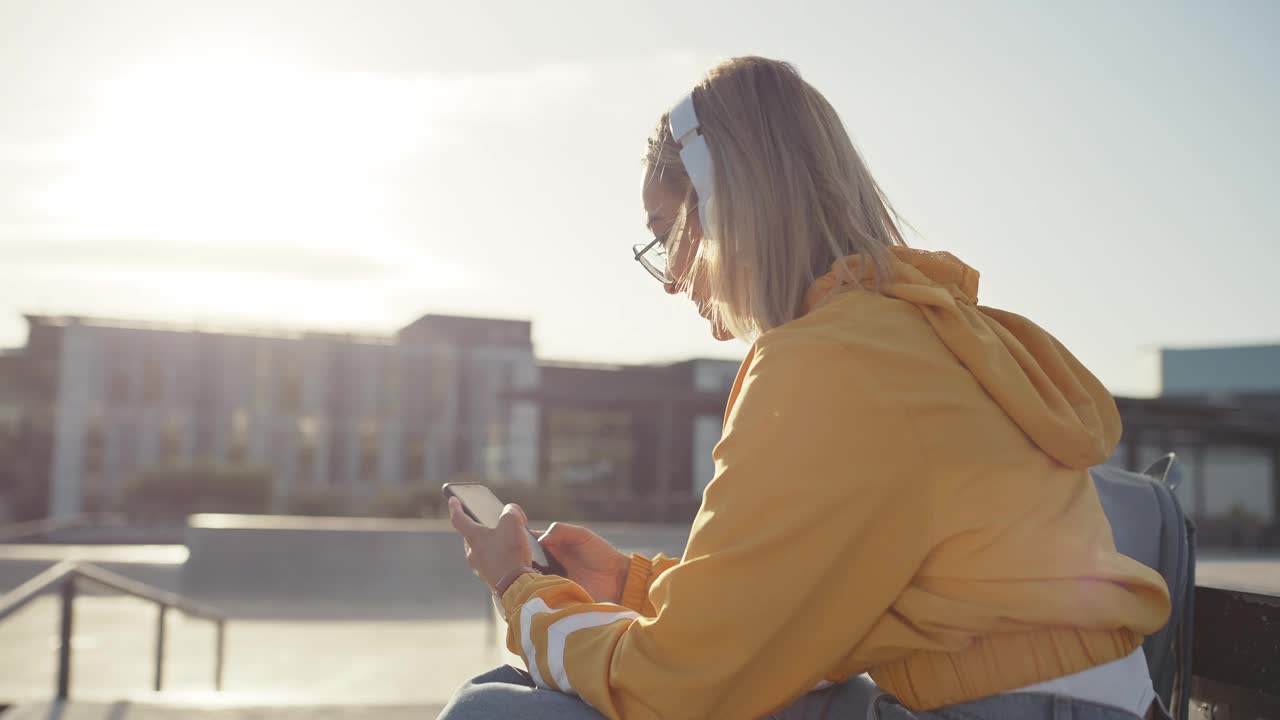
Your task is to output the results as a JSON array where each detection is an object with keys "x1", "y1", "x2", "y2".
[{"x1": 442, "y1": 58, "x2": 1169, "y2": 720}]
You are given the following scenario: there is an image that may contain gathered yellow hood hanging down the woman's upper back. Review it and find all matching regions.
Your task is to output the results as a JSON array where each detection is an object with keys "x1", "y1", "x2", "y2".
[{"x1": 805, "y1": 247, "x2": 1121, "y2": 469}]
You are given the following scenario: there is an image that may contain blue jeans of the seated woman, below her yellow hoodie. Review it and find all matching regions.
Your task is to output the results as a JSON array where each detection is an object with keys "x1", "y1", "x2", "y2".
[{"x1": 438, "y1": 665, "x2": 1169, "y2": 720}]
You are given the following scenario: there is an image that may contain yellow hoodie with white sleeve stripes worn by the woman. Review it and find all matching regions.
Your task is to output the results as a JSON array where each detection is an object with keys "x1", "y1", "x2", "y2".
[{"x1": 503, "y1": 249, "x2": 1169, "y2": 719}]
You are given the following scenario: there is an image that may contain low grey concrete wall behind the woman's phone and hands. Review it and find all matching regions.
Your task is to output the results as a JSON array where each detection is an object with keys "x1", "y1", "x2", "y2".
[{"x1": 182, "y1": 515, "x2": 689, "y2": 618}]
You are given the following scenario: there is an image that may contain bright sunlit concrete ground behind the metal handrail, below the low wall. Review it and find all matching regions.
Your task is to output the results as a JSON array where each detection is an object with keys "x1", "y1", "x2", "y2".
[{"x1": 0, "y1": 597, "x2": 512, "y2": 707}]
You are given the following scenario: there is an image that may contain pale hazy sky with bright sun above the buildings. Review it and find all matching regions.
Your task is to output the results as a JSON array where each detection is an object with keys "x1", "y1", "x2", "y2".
[{"x1": 0, "y1": 0, "x2": 1280, "y2": 396}]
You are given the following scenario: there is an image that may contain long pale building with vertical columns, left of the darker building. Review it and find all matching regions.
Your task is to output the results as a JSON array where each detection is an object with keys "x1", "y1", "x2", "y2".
[{"x1": 12, "y1": 315, "x2": 538, "y2": 515}]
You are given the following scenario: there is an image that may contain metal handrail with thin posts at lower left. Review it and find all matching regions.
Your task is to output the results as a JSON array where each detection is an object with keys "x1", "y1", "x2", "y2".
[{"x1": 0, "y1": 560, "x2": 227, "y2": 700}]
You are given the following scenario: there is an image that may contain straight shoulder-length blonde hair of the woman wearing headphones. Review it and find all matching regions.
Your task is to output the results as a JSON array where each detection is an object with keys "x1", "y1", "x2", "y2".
[{"x1": 646, "y1": 58, "x2": 906, "y2": 340}]
